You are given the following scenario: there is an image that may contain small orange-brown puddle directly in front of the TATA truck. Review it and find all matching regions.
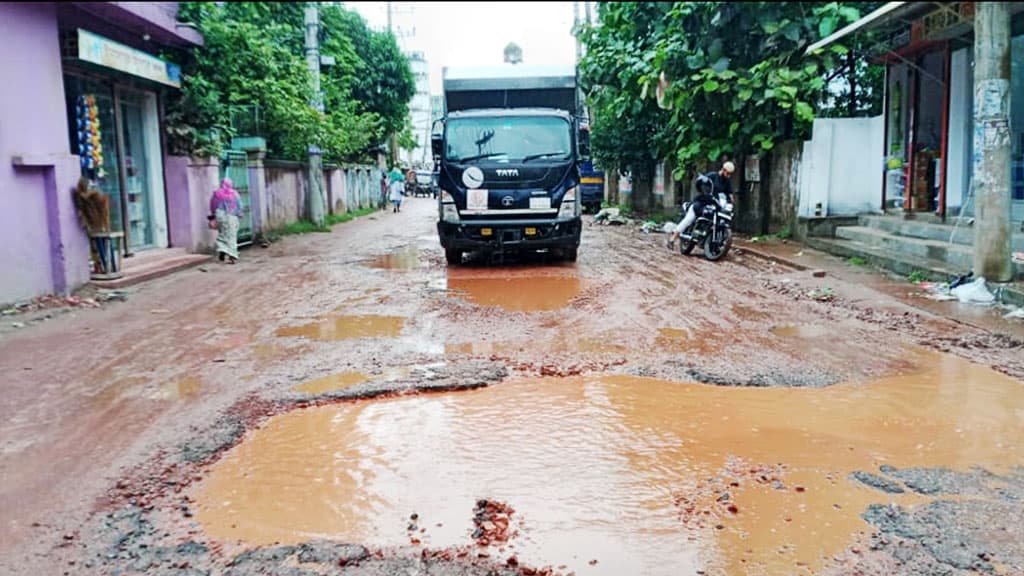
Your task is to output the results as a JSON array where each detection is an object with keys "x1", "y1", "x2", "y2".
[{"x1": 446, "y1": 273, "x2": 581, "y2": 312}]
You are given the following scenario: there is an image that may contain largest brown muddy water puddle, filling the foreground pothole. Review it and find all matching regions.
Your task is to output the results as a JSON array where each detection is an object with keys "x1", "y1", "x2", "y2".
[{"x1": 194, "y1": 351, "x2": 1024, "y2": 576}]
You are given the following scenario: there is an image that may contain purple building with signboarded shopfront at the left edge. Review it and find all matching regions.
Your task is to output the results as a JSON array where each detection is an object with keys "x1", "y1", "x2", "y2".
[{"x1": 0, "y1": 2, "x2": 203, "y2": 302}]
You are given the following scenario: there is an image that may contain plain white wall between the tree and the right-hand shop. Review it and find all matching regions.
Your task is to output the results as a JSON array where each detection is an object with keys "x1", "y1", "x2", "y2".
[{"x1": 797, "y1": 116, "x2": 885, "y2": 217}]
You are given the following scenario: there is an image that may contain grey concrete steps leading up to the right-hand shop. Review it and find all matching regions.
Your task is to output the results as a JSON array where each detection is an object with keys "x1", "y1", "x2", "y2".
[{"x1": 806, "y1": 215, "x2": 1024, "y2": 305}]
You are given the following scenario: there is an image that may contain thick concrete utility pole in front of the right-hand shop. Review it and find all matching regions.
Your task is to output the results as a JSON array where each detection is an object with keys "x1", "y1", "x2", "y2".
[{"x1": 974, "y1": 2, "x2": 1013, "y2": 282}]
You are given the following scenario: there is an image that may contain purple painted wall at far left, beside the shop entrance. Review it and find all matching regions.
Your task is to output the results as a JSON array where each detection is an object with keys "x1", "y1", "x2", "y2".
[{"x1": 0, "y1": 2, "x2": 88, "y2": 302}]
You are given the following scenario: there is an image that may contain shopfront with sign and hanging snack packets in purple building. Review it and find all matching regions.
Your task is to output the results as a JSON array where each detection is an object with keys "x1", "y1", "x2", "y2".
[{"x1": 60, "y1": 28, "x2": 180, "y2": 255}]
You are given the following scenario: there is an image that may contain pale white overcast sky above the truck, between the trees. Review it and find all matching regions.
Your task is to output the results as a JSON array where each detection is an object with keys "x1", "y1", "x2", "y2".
[{"x1": 344, "y1": 2, "x2": 584, "y2": 94}]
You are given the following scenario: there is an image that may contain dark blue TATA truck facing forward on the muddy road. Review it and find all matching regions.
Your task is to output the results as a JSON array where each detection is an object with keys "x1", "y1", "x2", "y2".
[{"x1": 431, "y1": 65, "x2": 589, "y2": 265}]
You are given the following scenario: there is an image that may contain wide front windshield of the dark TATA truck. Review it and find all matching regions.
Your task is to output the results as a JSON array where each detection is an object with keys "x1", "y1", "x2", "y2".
[{"x1": 445, "y1": 116, "x2": 572, "y2": 162}]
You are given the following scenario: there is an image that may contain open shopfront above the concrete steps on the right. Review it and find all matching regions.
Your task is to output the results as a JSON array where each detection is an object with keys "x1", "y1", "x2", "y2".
[{"x1": 876, "y1": 2, "x2": 1024, "y2": 228}]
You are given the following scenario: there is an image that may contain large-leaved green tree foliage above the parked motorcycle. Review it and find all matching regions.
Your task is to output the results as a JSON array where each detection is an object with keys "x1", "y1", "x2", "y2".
[{"x1": 581, "y1": 2, "x2": 881, "y2": 177}]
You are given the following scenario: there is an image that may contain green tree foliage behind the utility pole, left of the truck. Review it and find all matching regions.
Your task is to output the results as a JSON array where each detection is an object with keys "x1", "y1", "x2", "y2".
[{"x1": 167, "y1": 2, "x2": 415, "y2": 161}]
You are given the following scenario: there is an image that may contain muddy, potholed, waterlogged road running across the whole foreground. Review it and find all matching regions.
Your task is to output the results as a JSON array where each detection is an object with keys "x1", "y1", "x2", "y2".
[{"x1": 0, "y1": 194, "x2": 1024, "y2": 576}]
